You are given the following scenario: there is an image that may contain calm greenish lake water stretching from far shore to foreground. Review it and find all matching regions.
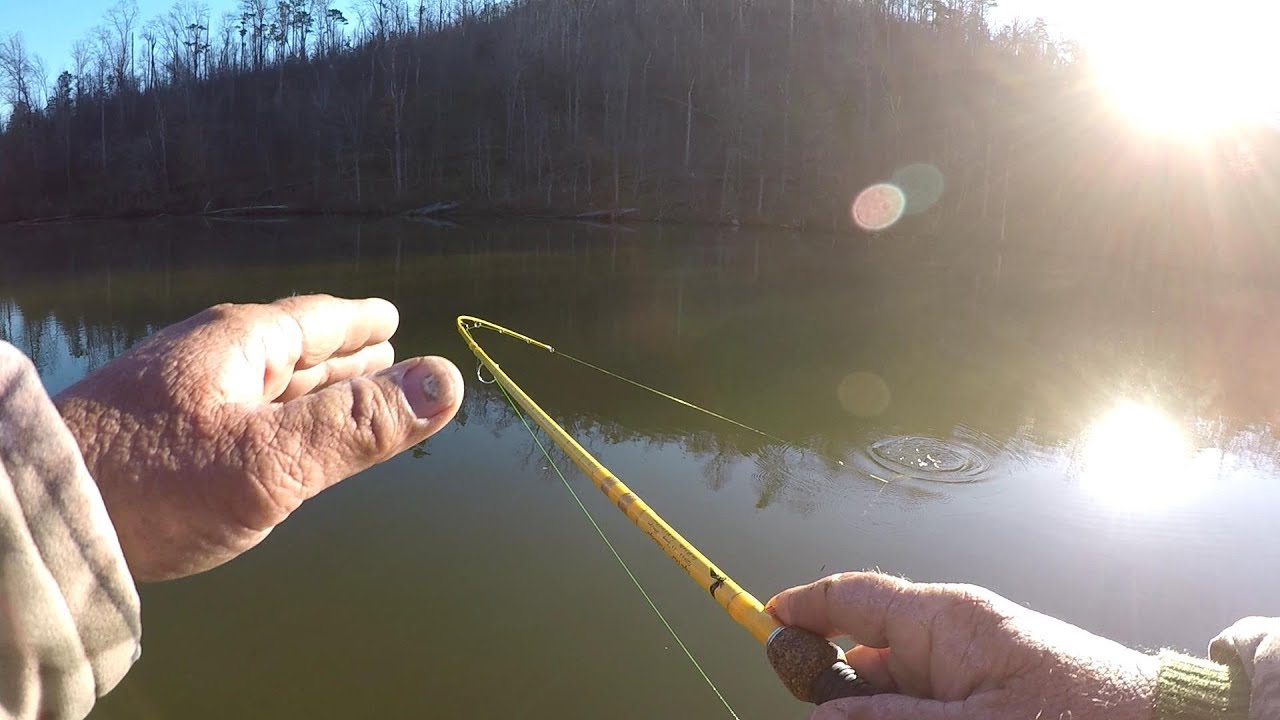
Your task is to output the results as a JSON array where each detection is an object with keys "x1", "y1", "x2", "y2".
[{"x1": 0, "y1": 220, "x2": 1280, "y2": 719}]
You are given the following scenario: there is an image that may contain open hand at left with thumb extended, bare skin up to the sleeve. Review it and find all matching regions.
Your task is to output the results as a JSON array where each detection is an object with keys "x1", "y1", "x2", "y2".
[{"x1": 55, "y1": 296, "x2": 463, "y2": 580}]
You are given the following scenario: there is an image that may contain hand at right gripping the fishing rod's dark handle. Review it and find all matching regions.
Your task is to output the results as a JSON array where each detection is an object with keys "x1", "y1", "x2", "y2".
[{"x1": 767, "y1": 573, "x2": 1157, "y2": 720}]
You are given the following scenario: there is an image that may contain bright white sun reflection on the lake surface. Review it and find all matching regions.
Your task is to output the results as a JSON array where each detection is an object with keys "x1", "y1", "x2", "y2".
[{"x1": 1079, "y1": 402, "x2": 1213, "y2": 511}]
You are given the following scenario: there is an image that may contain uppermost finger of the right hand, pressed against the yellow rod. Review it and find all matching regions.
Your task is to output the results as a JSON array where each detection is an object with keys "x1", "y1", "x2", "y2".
[{"x1": 765, "y1": 573, "x2": 928, "y2": 647}]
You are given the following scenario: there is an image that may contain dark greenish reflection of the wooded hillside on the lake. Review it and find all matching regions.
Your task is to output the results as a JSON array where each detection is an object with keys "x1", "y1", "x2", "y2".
[{"x1": 0, "y1": 222, "x2": 1280, "y2": 505}]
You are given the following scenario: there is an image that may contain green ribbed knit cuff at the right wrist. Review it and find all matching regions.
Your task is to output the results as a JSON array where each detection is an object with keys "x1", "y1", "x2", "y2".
[{"x1": 1156, "y1": 650, "x2": 1249, "y2": 720}]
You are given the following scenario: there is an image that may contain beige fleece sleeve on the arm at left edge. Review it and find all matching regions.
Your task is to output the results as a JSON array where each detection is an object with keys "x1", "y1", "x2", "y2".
[{"x1": 0, "y1": 342, "x2": 142, "y2": 720}]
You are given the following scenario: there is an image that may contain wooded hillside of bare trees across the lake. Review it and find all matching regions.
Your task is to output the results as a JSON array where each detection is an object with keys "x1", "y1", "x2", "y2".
[{"x1": 0, "y1": 0, "x2": 1280, "y2": 254}]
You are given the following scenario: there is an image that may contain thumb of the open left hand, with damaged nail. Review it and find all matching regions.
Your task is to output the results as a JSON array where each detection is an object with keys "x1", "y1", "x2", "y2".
[{"x1": 266, "y1": 357, "x2": 463, "y2": 500}]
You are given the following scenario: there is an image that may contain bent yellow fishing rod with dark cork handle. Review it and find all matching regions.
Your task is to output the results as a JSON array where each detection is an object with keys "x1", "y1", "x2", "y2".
[{"x1": 457, "y1": 315, "x2": 873, "y2": 705}]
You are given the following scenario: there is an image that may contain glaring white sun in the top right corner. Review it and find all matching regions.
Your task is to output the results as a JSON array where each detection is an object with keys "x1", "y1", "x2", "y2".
[{"x1": 1087, "y1": 0, "x2": 1280, "y2": 140}]
